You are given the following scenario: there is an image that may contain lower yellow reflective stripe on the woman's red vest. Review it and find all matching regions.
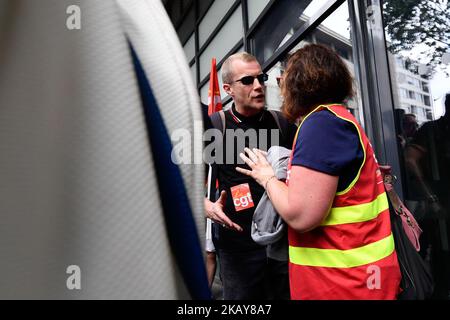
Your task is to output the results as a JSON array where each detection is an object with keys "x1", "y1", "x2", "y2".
[{"x1": 289, "y1": 233, "x2": 395, "y2": 268}]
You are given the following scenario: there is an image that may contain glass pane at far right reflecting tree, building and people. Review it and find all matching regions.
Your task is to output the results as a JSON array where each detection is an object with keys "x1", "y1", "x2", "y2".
[{"x1": 383, "y1": 0, "x2": 450, "y2": 299}]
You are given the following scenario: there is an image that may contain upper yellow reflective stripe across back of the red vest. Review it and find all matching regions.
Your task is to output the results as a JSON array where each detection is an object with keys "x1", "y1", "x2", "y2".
[{"x1": 320, "y1": 192, "x2": 389, "y2": 226}]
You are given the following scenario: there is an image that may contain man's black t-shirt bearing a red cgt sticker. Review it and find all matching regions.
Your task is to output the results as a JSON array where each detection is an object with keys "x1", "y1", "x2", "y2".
[{"x1": 213, "y1": 104, "x2": 297, "y2": 252}]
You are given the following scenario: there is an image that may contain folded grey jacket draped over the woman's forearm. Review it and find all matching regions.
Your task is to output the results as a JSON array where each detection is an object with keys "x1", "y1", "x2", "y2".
[{"x1": 251, "y1": 146, "x2": 291, "y2": 261}]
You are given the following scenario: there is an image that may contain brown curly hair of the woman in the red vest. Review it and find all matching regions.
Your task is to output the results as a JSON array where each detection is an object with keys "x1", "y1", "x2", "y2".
[{"x1": 281, "y1": 44, "x2": 353, "y2": 121}]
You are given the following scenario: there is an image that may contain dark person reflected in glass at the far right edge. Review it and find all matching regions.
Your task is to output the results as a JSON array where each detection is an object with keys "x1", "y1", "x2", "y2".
[{"x1": 405, "y1": 93, "x2": 450, "y2": 298}]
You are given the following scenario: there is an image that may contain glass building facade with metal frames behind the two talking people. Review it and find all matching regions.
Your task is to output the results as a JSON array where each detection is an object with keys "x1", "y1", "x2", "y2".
[{"x1": 163, "y1": 0, "x2": 450, "y2": 299}]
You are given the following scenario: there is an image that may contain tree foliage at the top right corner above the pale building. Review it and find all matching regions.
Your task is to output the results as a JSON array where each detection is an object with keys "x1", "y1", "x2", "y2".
[{"x1": 383, "y1": 0, "x2": 450, "y2": 75}]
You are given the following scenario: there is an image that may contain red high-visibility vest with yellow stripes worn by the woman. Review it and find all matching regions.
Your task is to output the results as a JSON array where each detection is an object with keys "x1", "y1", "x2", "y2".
[{"x1": 286, "y1": 105, "x2": 401, "y2": 300}]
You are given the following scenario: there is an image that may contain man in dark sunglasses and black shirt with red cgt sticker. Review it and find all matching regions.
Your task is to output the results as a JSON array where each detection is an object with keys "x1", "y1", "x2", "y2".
[{"x1": 205, "y1": 52, "x2": 296, "y2": 300}]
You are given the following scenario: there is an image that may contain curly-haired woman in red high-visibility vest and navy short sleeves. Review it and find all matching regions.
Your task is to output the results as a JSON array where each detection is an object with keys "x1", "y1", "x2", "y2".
[{"x1": 237, "y1": 44, "x2": 401, "y2": 299}]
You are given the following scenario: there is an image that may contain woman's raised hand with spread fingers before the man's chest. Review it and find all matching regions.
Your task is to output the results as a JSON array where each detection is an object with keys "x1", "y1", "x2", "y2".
[{"x1": 236, "y1": 148, "x2": 276, "y2": 188}]
